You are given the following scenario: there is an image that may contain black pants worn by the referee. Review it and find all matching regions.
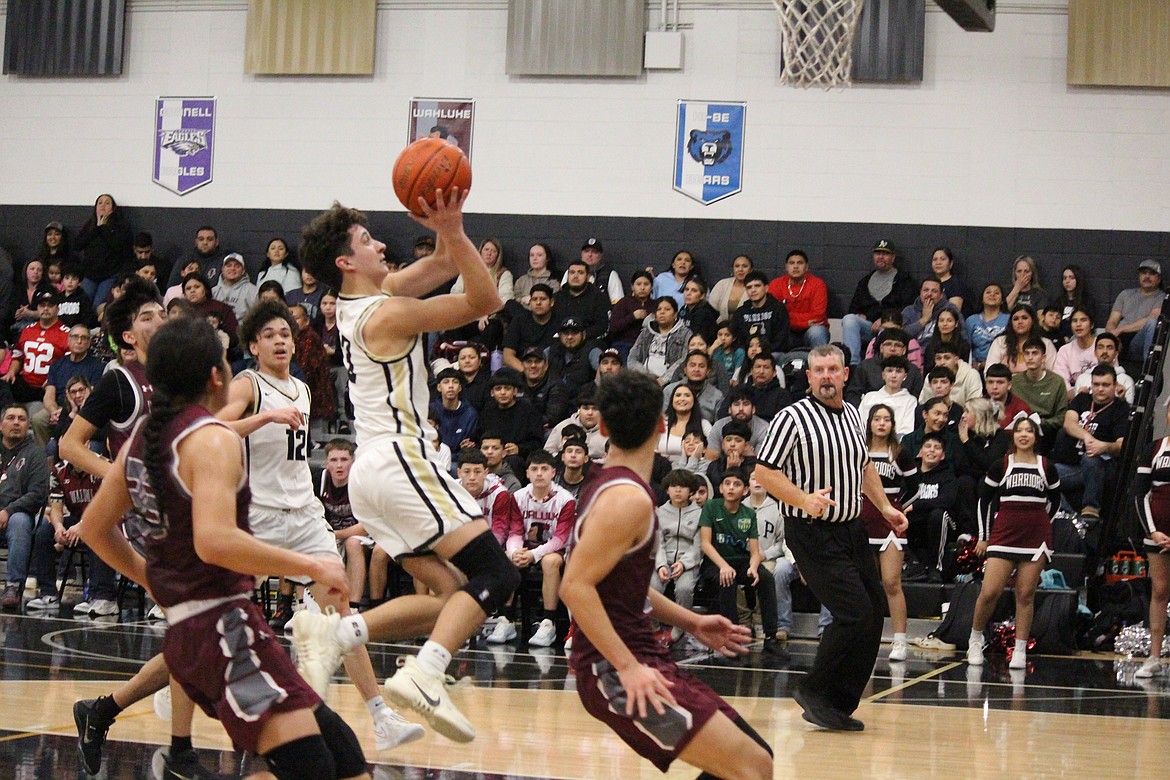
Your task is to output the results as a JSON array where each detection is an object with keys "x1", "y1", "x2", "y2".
[{"x1": 784, "y1": 518, "x2": 886, "y2": 715}]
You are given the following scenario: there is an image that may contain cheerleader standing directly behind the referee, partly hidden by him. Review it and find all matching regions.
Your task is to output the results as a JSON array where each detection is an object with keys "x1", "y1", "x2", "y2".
[{"x1": 861, "y1": 403, "x2": 917, "y2": 661}]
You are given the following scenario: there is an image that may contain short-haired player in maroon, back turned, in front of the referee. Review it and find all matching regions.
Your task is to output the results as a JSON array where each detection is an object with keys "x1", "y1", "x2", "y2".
[{"x1": 560, "y1": 371, "x2": 772, "y2": 779}]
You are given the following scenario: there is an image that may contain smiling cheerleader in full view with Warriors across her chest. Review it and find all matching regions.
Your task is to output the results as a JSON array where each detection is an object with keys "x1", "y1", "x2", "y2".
[{"x1": 966, "y1": 412, "x2": 1060, "y2": 669}]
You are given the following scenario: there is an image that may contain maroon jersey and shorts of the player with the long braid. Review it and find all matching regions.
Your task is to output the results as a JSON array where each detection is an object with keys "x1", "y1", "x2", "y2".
[{"x1": 125, "y1": 406, "x2": 321, "y2": 752}]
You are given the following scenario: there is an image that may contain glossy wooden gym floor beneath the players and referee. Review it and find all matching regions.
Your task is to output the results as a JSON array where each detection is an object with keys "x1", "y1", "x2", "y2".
[{"x1": 0, "y1": 613, "x2": 1170, "y2": 780}]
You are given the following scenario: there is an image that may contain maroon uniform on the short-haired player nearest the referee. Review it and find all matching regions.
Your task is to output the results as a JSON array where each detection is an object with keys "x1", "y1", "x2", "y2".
[{"x1": 569, "y1": 467, "x2": 739, "y2": 772}]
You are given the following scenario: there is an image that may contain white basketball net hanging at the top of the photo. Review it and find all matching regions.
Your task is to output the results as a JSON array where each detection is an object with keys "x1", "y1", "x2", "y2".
[{"x1": 772, "y1": 0, "x2": 865, "y2": 89}]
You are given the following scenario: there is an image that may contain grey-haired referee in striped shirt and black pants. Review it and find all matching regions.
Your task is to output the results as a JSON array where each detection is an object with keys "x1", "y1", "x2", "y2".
[{"x1": 756, "y1": 344, "x2": 907, "y2": 731}]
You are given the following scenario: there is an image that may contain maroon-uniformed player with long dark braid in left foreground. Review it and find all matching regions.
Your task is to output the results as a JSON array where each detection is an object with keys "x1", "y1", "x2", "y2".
[{"x1": 82, "y1": 318, "x2": 370, "y2": 780}]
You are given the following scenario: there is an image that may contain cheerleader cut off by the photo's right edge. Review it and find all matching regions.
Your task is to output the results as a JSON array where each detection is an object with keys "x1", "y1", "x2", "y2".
[{"x1": 1134, "y1": 407, "x2": 1170, "y2": 677}]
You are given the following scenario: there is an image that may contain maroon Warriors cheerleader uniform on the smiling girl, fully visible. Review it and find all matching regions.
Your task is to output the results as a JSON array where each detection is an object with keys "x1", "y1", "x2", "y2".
[{"x1": 979, "y1": 455, "x2": 1060, "y2": 561}]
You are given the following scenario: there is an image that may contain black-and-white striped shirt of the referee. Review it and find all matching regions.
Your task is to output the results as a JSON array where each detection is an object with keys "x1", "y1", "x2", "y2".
[{"x1": 756, "y1": 395, "x2": 869, "y2": 523}]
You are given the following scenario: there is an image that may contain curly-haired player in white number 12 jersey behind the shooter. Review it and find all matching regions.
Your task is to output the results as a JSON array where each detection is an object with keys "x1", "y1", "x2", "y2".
[{"x1": 215, "y1": 302, "x2": 425, "y2": 751}]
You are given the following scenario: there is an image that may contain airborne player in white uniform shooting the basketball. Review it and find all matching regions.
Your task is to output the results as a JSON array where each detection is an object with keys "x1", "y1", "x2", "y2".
[{"x1": 293, "y1": 189, "x2": 519, "y2": 741}]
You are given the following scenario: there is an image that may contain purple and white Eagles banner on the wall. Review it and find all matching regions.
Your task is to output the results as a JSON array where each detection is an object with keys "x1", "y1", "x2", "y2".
[{"x1": 154, "y1": 97, "x2": 215, "y2": 195}]
